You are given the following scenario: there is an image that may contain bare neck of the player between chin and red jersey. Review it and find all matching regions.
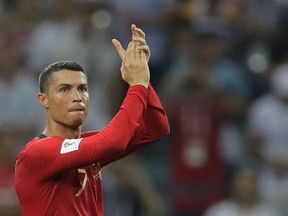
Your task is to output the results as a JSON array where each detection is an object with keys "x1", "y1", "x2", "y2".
[{"x1": 43, "y1": 125, "x2": 81, "y2": 139}]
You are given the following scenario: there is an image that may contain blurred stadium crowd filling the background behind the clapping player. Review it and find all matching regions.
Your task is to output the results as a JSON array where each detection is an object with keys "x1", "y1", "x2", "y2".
[{"x1": 0, "y1": 0, "x2": 288, "y2": 216}]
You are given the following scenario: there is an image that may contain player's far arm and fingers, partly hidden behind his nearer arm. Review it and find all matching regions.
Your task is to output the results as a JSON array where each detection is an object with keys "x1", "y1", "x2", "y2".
[{"x1": 101, "y1": 24, "x2": 170, "y2": 166}]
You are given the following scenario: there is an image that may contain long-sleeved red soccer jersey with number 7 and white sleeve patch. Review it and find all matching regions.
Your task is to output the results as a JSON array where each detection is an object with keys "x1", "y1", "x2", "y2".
[{"x1": 15, "y1": 85, "x2": 169, "y2": 216}]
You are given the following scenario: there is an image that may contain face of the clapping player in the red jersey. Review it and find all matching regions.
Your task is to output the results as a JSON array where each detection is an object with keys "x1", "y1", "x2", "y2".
[{"x1": 40, "y1": 70, "x2": 89, "y2": 128}]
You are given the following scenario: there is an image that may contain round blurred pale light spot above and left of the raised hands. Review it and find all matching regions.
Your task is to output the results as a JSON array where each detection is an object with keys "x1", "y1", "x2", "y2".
[{"x1": 92, "y1": 10, "x2": 112, "y2": 29}]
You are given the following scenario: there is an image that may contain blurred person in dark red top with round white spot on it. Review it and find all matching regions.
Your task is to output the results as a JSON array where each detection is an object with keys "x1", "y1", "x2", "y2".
[{"x1": 166, "y1": 63, "x2": 225, "y2": 216}]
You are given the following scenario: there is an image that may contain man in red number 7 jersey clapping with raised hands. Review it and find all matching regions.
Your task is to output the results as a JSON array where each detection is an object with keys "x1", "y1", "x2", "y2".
[{"x1": 15, "y1": 25, "x2": 170, "y2": 216}]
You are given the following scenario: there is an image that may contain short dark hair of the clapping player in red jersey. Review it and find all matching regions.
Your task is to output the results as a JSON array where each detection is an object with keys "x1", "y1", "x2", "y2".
[{"x1": 39, "y1": 60, "x2": 84, "y2": 93}]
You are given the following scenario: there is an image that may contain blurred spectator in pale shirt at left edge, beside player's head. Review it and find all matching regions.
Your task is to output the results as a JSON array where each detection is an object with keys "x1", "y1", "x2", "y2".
[{"x1": 0, "y1": 36, "x2": 45, "y2": 143}]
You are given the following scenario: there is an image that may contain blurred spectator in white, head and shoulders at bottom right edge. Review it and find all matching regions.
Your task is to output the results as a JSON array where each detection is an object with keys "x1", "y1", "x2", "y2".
[{"x1": 204, "y1": 168, "x2": 280, "y2": 216}]
